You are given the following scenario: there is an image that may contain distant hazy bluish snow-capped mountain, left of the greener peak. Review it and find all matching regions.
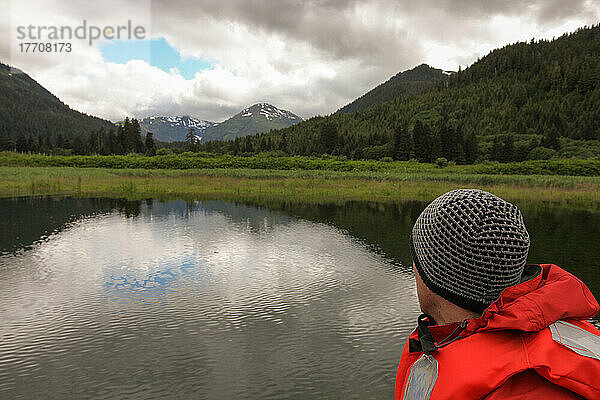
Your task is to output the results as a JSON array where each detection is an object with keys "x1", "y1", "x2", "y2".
[{"x1": 140, "y1": 115, "x2": 219, "y2": 142}]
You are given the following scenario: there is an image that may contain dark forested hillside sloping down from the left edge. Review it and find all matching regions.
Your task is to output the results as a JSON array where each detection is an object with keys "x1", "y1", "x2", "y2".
[{"x1": 0, "y1": 63, "x2": 113, "y2": 142}]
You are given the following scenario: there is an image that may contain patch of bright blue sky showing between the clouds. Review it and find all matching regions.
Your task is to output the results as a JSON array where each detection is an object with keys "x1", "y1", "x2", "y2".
[{"x1": 98, "y1": 38, "x2": 214, "y2": 79}]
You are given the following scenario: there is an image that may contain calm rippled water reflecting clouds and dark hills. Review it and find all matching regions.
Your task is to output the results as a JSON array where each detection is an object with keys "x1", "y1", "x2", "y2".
[{"x1": 0, "y1": 198, "x2": 600, "y2": 399}]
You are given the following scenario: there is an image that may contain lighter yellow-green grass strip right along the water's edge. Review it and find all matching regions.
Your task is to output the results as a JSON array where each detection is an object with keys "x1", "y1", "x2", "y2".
[{"x1": 0, "y1": 167, "x2": 600, "y2": 211}]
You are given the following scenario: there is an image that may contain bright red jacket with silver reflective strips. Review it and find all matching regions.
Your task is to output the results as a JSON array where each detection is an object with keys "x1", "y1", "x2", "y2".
[{"x1": 395, "y1": 264, "x2": 600, "y2": 400}]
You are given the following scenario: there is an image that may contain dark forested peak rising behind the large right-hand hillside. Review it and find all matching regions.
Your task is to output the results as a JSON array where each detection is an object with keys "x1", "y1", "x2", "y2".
[{"x1": 337, "y1": 64, "x2": 451, "y2": 114}]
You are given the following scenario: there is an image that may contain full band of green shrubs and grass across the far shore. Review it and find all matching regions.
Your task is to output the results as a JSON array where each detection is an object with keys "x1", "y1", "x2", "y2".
[{"x1": 0, "y1": 152, "x2": 600, "y2": 211}]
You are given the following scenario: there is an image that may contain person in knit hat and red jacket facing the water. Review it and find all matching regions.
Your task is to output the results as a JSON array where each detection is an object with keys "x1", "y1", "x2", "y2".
[{"x1": 396, "y1": 189, "x2": 600, "y2": 400}]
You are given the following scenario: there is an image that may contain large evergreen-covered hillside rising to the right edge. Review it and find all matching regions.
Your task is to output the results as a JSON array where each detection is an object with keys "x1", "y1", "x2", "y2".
[{"x1": 202, "y1": 25, "x2": 600, "y2": 162}]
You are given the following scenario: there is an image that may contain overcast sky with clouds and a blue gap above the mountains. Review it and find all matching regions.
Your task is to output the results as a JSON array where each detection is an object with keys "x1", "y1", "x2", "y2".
[{"x1": 0, "y1": 0, "x2": 600, "y2": 121}]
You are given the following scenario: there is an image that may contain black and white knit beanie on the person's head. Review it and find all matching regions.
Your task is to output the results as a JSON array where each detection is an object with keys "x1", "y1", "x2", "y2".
[{"x1": 410, "y1": 189, "x2": 529, "y2": 312}]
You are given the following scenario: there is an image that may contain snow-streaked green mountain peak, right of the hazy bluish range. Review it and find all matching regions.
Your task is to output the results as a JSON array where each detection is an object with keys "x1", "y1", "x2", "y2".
[{"x1": 202, "y1": 103, "x2": 302, "y2": 142}]
